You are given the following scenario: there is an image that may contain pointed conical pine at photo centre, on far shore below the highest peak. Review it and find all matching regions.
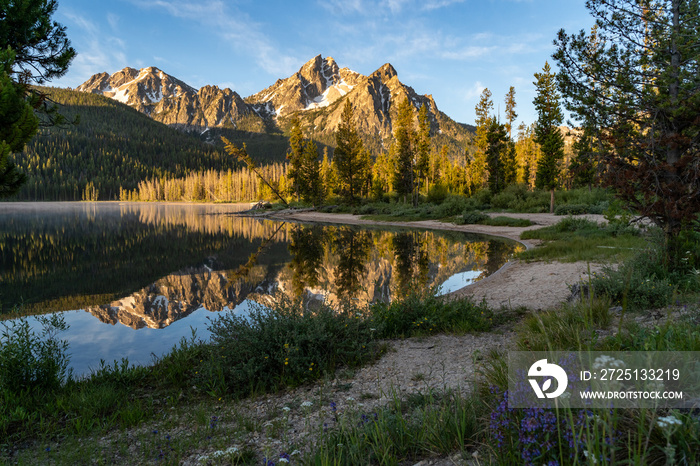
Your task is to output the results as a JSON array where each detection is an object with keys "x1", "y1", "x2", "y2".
[{"x1": 333, "y1": 99, "x2": 364, "y2": 204}]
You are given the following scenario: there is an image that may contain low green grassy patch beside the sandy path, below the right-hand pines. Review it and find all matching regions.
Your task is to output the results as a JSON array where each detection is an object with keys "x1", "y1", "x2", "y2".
[{"x1": 519, "y1": 217, "x2": 649, "y2": 262}]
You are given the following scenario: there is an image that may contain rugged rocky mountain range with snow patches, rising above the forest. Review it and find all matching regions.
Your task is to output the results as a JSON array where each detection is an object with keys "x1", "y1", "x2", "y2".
[{"x1": 77, "y1": 55, "x2": 473, "y2": 155}]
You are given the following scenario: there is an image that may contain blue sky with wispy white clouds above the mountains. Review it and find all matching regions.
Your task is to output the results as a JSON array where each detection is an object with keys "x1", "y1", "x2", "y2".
[{"x1": 52, "y1": 0, "x2": 593, "y2": 127}]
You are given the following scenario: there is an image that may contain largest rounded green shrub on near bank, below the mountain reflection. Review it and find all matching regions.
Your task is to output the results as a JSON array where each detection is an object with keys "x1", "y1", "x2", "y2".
[{"x1": 198, "y1": 301, "x2": 379, "y2": 396}]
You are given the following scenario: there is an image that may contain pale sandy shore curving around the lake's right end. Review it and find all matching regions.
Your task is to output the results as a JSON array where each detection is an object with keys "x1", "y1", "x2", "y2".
[{"x1": 272, "y1": 212, "x2": 605, "y2": 310}]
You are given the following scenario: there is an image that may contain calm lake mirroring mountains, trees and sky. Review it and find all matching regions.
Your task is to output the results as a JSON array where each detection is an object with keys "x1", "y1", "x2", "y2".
[{"x1": 0, "y1": 202, "x2": 522, "y2": 375}]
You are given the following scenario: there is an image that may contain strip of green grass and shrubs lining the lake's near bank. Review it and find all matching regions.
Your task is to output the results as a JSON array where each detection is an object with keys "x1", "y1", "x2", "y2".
[{"x1": 0, "y1": 295, "x2": 502, "y2": 462}]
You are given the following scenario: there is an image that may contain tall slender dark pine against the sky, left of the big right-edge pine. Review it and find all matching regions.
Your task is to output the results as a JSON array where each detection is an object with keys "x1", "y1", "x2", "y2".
[{"x1": 533, "y1": 62, "x2": 564, "y2": 213}]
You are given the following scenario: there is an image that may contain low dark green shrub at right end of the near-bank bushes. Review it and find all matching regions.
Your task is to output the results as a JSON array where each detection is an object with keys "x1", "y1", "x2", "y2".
[{"x1": 372, "y1": 293, "x2": 494, "y2": 338}]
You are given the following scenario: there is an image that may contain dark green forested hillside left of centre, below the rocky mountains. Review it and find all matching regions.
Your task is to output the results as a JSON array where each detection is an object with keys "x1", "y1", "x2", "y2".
[{"x1": 9, "y1": 88, "x2": 287, "y2": 200}]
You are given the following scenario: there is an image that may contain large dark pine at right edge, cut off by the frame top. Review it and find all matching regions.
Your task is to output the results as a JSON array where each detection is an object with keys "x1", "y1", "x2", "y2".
[{"x1": 554, "y1": 0, "x2": 700, "y2": 255}]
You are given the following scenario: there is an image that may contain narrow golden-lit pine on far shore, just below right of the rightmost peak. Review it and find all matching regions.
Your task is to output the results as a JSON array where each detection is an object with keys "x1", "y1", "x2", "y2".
[{"x1": 394, "y1": 97, "x2": 416, "y2": 202}]
